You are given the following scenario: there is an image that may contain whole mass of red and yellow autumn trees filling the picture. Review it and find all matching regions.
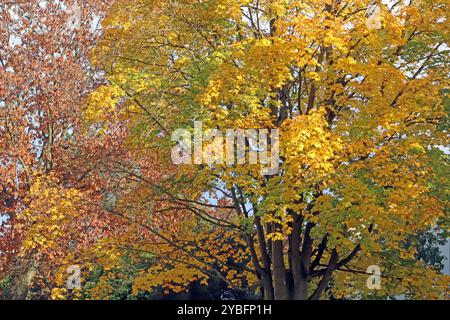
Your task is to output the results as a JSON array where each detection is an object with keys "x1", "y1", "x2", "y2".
[{"x1": 0, "y1": 0, "x2": 450, "y2": 300}]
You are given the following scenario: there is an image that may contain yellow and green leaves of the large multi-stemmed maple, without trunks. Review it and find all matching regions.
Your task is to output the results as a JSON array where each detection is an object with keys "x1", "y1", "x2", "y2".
[{"x1": 79, "y1": 0, "x2": 448, "y2": 297}]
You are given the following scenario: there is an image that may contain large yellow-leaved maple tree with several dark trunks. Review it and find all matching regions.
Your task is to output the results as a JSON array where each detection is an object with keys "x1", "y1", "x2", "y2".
[{"x1": 85, "y1": 0, "x2": 449, "y2": 299}]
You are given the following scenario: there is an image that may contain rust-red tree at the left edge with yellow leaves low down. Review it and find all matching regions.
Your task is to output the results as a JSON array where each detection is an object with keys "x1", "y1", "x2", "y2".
[{"x1": 0, "y1": 0, "x2": 114, "y2": 299}]
